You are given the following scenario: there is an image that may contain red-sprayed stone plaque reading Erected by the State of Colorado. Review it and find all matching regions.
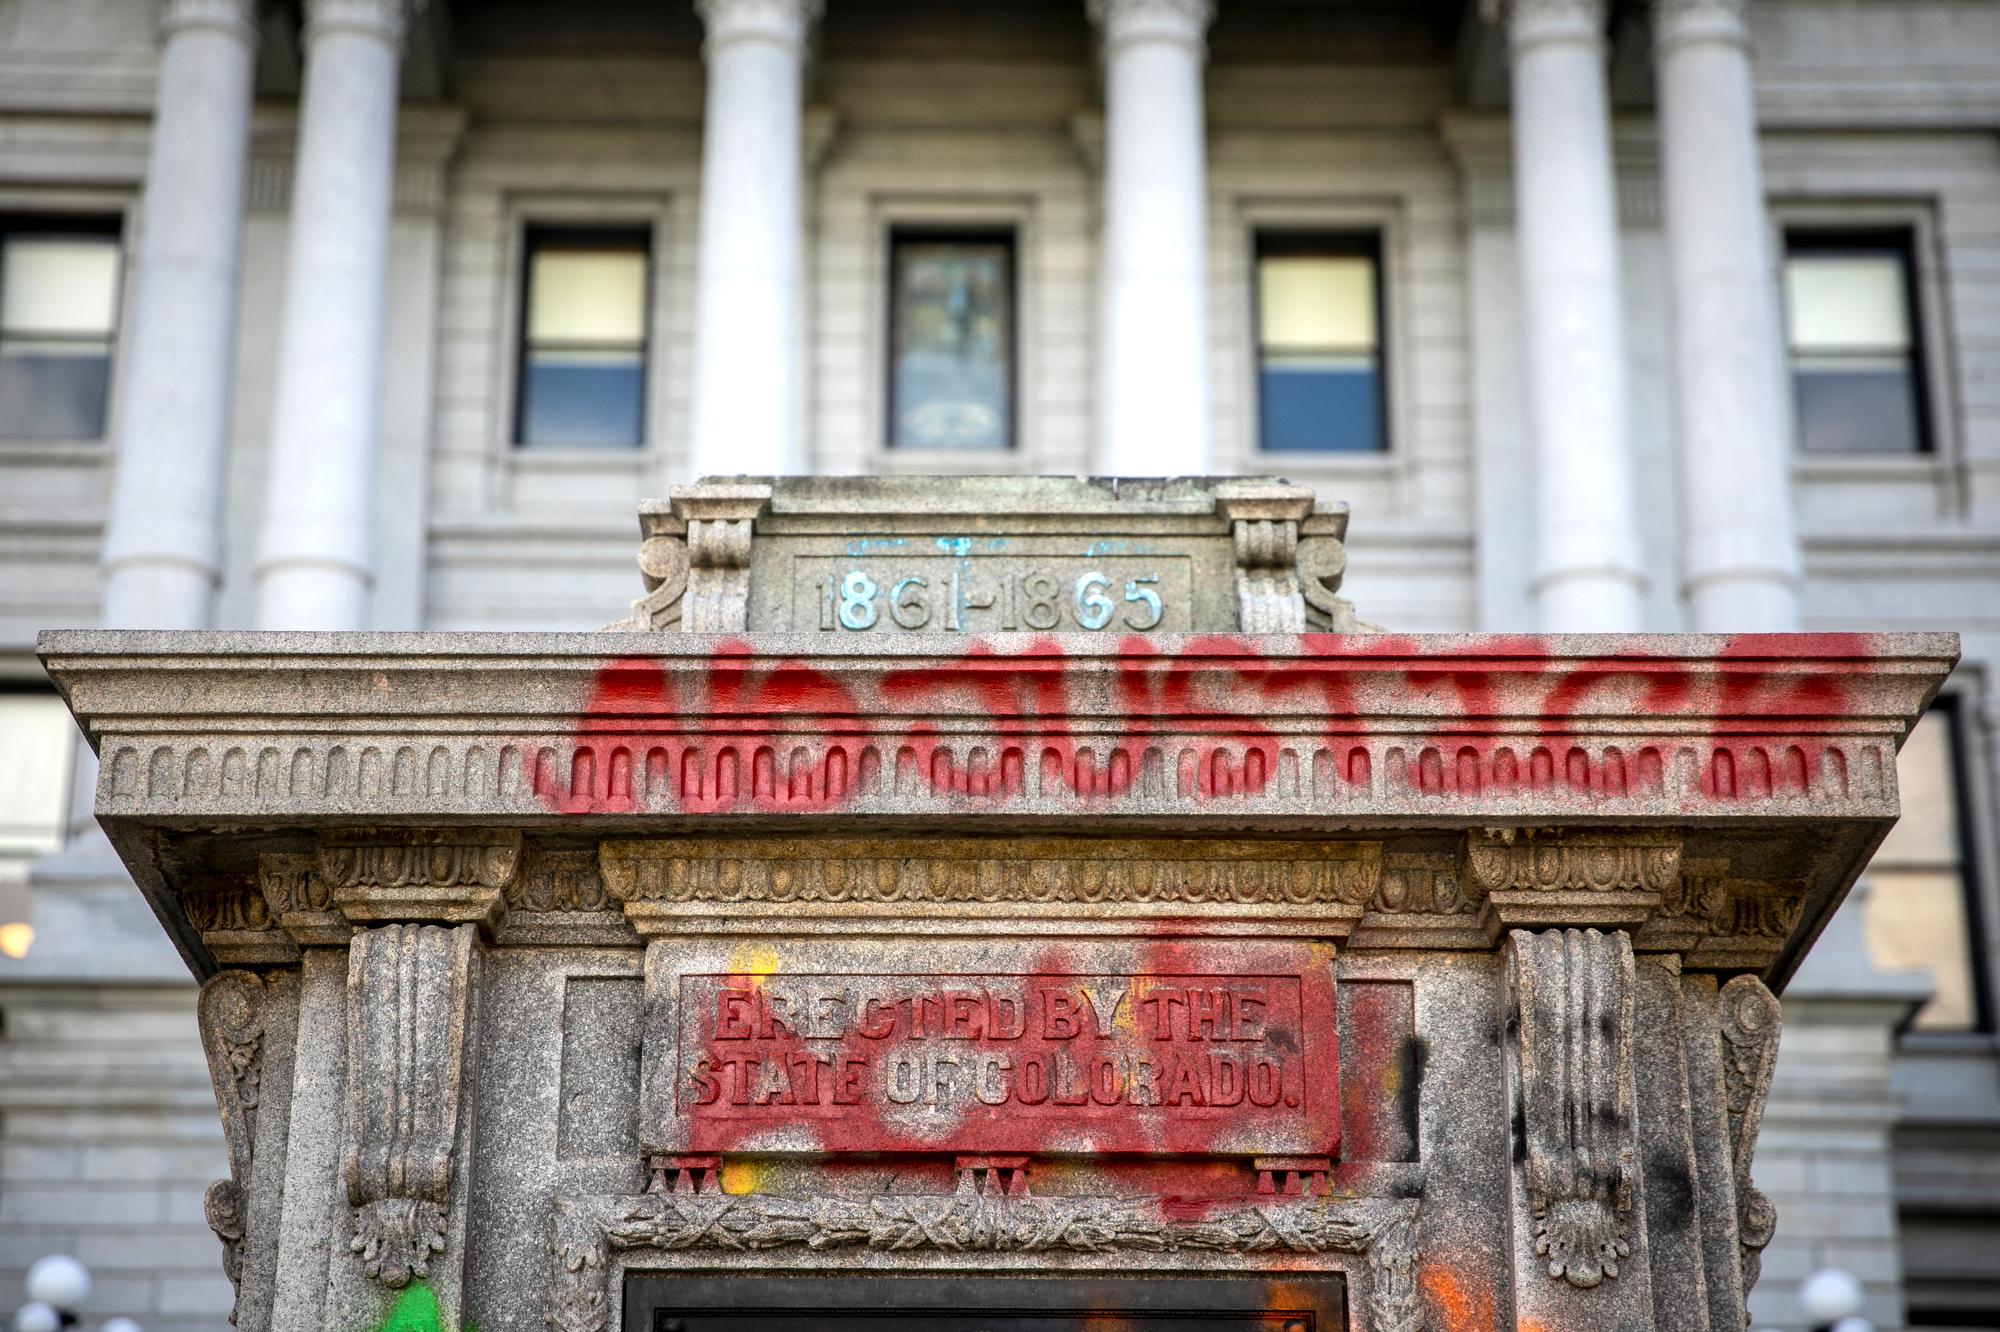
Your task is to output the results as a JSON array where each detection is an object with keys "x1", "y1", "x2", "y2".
[{"x1": 648, "y1": 944, "x2": 1340, "y2": 1156}]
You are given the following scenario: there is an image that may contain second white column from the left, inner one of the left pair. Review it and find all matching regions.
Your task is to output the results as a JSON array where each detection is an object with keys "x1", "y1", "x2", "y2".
[{"x1": 256, "y1": 0, "x2": 406, "y2": 630}]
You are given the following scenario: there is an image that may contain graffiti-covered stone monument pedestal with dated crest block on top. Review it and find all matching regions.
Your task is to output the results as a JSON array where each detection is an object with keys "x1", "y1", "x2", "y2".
[{"x1": 42, "y1": 480, "x2": 1956, "y2": 1332}]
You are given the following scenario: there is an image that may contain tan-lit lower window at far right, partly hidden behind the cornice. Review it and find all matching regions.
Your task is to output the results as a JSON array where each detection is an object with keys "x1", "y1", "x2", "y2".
[{"x1": 1862, "y1": 702, "x2": 1980, "y2": 1030}]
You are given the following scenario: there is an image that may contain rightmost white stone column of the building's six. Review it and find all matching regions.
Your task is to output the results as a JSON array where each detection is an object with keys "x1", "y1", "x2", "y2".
[{"x1": 1652, "y1": 0, "x2": 1800, "y2": 632}]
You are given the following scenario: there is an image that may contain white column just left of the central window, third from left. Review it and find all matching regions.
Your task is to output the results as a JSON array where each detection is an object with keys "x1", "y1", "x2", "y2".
[{"x1": 692, "y1": 0, "x2": 820, "y2": 476}]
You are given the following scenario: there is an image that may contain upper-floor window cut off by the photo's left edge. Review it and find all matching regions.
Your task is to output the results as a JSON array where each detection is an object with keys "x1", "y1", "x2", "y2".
[{"x1": 0, "y1": 218, "x2": 118, "y2": 440}]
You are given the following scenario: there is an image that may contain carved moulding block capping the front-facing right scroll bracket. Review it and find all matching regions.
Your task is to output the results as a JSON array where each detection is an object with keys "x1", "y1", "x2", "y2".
[{"x1": 1466, "y1": 828, "x2": 1680, "y2": 940}]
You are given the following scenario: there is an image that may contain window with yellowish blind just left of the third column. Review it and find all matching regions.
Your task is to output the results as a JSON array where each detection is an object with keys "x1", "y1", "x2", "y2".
[{"x1": 514, "y1": 228, "x2": 652, "y2": 448}]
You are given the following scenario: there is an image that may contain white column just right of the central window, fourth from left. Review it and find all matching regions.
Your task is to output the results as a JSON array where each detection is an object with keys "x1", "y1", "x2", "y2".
[{"x1": 1090, "y1": 0, "x2": 1214, "y2": 476}]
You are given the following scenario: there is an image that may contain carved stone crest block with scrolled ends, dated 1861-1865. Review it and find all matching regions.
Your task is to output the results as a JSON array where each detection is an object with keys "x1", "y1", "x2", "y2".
[{"x1": 610, "y1": 476, "x2": 1372, "y2": 636}]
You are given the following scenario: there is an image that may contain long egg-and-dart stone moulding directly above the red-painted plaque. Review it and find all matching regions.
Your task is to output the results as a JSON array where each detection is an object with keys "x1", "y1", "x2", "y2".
[{"x1": 598, "y1": 836, "x2": 1382, "y2": 936}]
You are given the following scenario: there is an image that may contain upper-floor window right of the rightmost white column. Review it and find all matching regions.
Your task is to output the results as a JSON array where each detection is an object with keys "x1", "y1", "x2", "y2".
[{"x1": 1784, "y1": 232, "x2": 1930, "y2": 454}]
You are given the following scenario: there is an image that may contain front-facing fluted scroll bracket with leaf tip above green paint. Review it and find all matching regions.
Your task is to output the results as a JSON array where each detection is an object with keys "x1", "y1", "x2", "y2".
[{"x1": 342, "y1": 924, "x2": 478, "y2": 1290}]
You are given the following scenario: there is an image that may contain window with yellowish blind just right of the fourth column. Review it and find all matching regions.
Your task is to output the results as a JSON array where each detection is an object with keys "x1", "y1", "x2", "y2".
[{"x1": 1256, "y1": 232, "x2": 1388, "y2": 454}]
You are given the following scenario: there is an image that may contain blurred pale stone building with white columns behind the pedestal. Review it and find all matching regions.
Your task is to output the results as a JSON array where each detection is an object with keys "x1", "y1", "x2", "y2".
[{"x1": 0, "y1": 0, "x2": 2000, "y2": 1330}]
